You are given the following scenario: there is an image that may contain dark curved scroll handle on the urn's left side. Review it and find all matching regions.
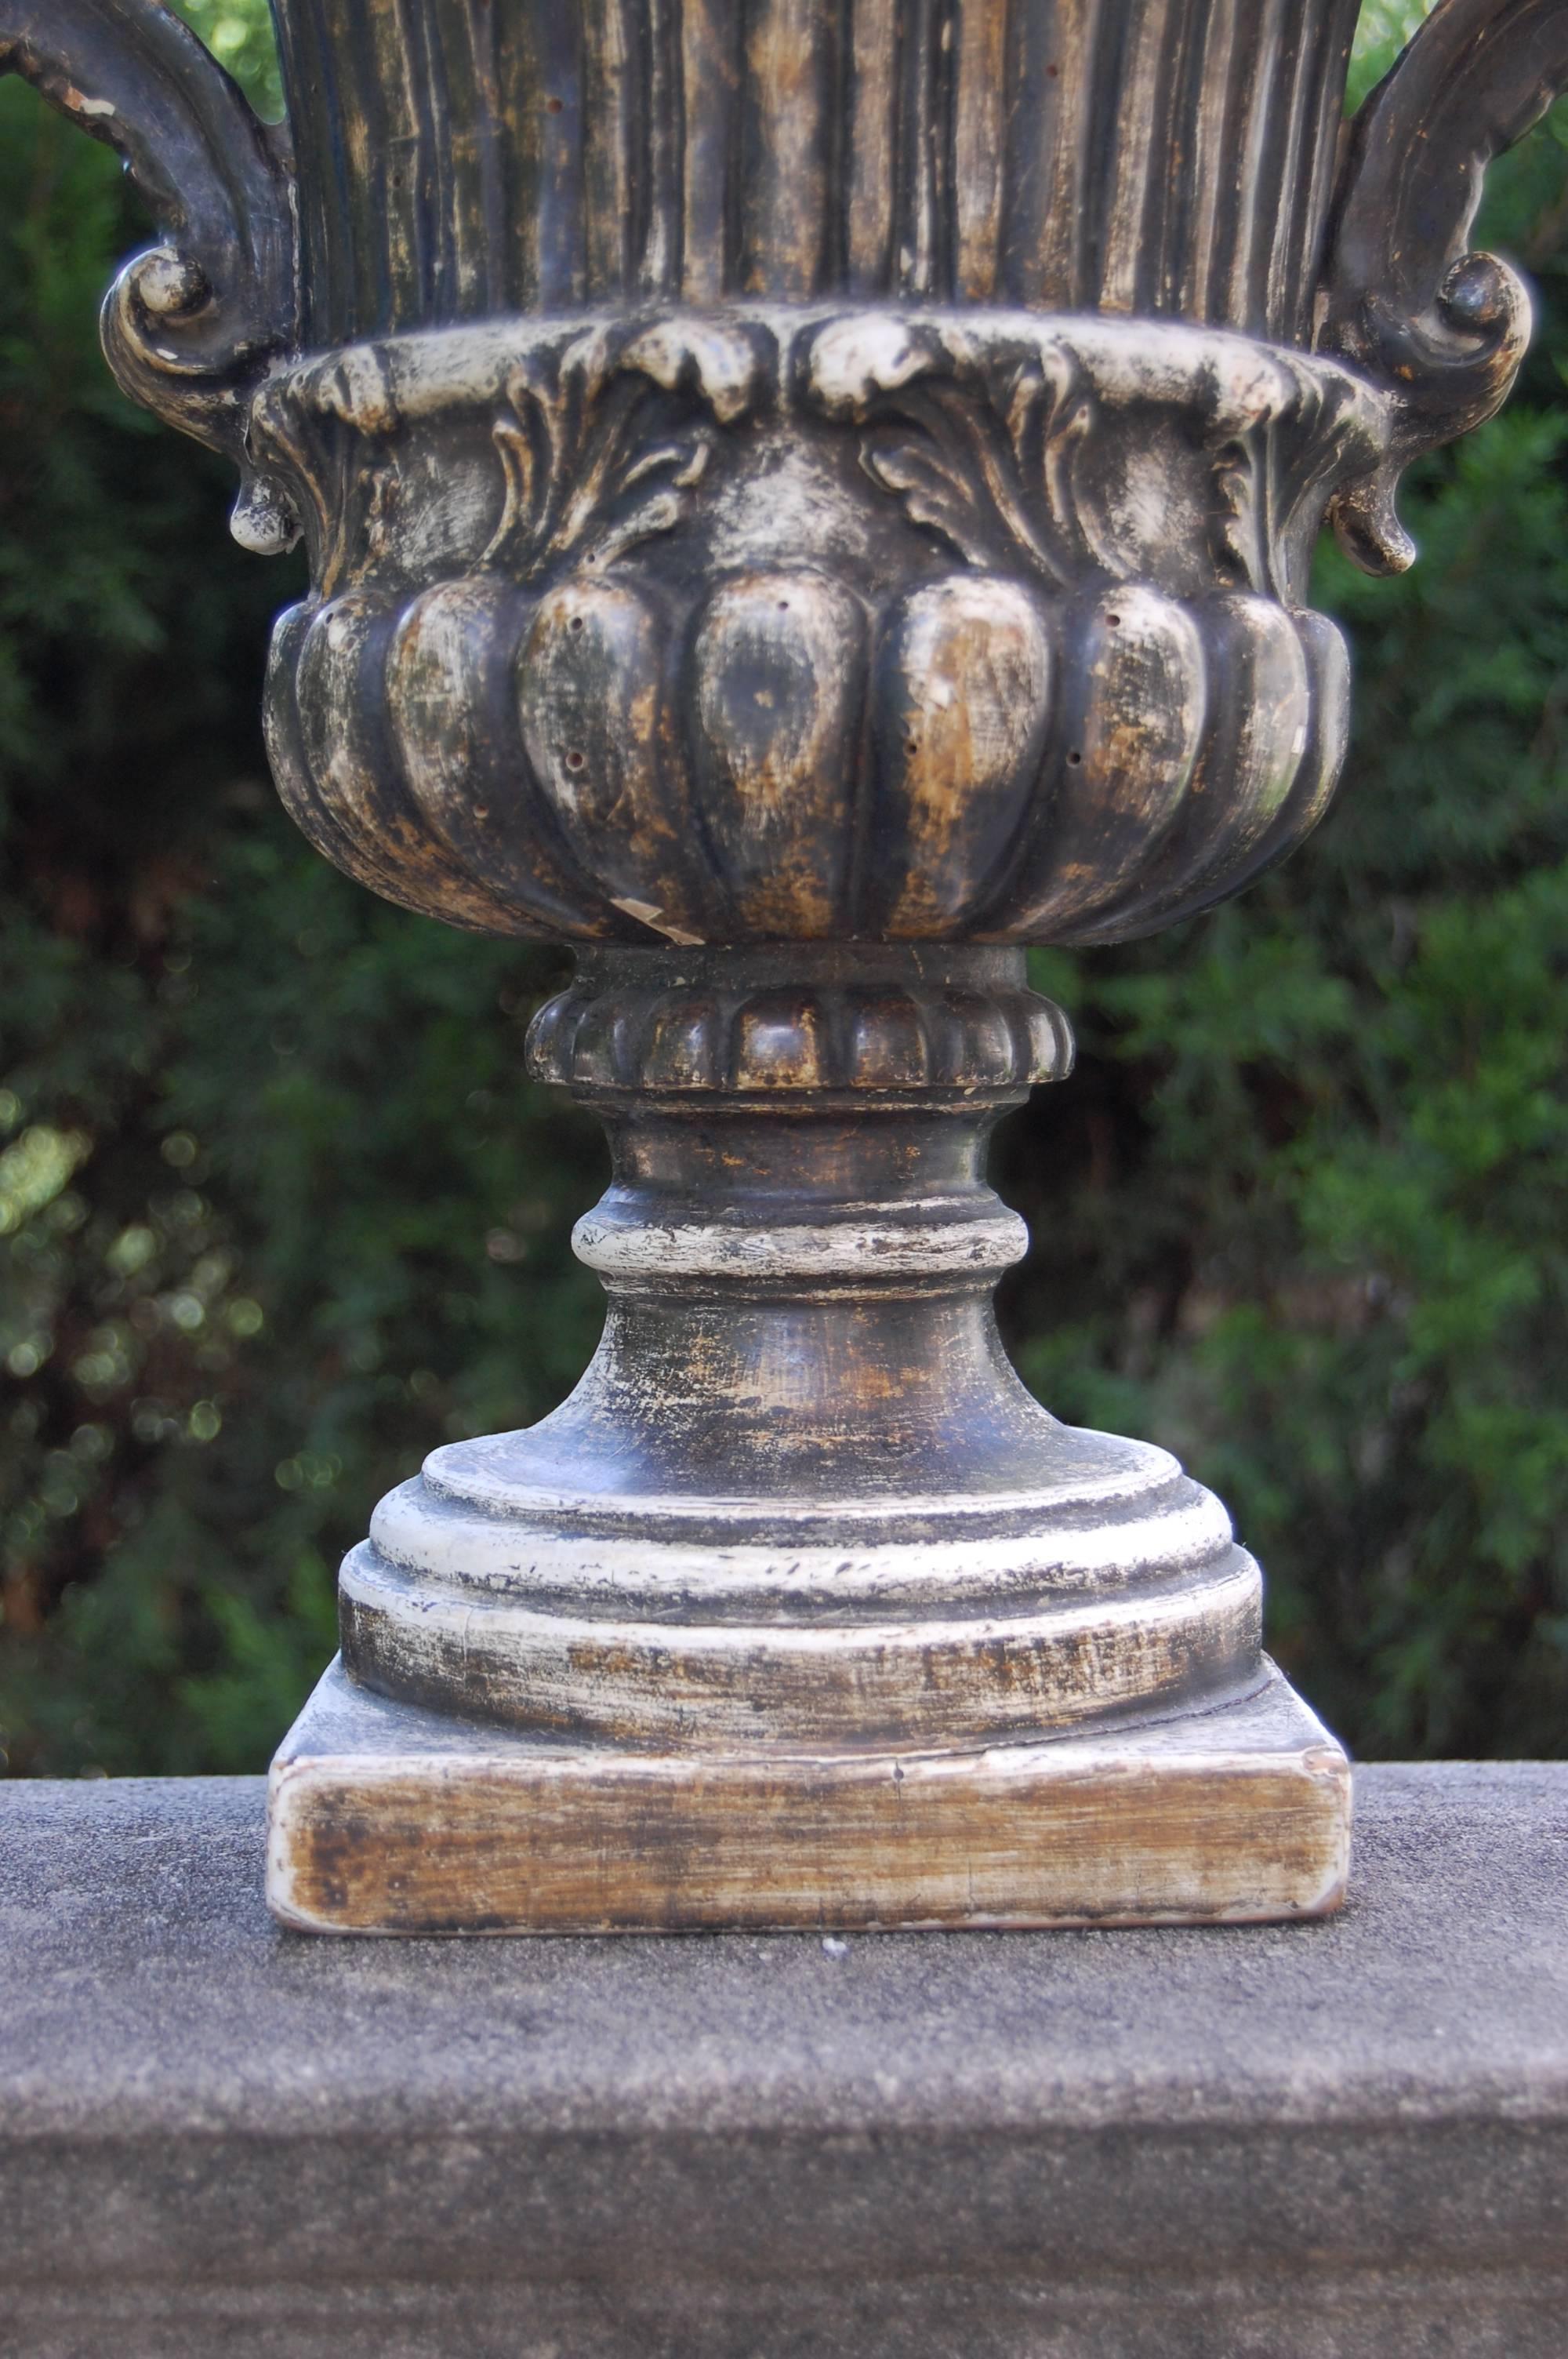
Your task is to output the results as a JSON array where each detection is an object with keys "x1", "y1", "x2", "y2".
[{"x1": 0, "y1": 0, "x2": 297, "y2": 552}]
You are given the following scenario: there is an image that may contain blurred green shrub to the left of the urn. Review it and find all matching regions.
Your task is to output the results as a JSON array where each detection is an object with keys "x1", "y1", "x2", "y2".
[{"x1": 0, "y1": 27, "x2": 601, "y2": 1772}]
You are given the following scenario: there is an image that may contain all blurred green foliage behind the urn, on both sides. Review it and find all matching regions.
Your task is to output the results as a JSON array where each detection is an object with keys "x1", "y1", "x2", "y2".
[{"x1": 0, "y1": 0, "x2": 1568, "y2": 1774}]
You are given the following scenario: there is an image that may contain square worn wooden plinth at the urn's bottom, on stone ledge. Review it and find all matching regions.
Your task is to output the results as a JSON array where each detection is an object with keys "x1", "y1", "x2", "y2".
[{"x1": 267, "y1": 1663, "x2": 1351, "y2": 1935}]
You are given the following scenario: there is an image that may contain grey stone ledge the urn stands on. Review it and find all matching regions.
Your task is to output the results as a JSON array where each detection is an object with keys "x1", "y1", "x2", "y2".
[{"x1": 0, "y1": 1765, "x2": 1568, "y2": 2359}]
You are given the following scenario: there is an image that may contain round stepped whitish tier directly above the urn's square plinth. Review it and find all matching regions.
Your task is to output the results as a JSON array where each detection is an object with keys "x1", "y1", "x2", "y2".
[{"x1": 339, "y1": 1411, "x2": 1261, "y2": 1750}]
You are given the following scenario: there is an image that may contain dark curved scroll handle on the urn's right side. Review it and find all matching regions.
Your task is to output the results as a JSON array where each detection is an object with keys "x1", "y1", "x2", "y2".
[{"x1": 1318, "y1": 0, "x2": 1568, "y2": 573}]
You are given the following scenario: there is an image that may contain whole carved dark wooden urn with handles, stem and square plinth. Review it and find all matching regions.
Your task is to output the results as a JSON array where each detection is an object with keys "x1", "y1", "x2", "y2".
[{"x1": 12, "y1": 0, "x2": 1568, "y2": 1932}]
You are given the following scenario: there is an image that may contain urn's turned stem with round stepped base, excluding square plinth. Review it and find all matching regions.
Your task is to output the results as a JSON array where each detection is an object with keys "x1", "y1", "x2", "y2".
[{"x1": 342, "y1": 946, "x2": 1264, "y2": 1750}]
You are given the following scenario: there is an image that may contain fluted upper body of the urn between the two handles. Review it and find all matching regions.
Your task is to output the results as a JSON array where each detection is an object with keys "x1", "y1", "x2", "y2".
[{"x1": 278, "y1": 0, "x2": 1360, "y2": 344}]
